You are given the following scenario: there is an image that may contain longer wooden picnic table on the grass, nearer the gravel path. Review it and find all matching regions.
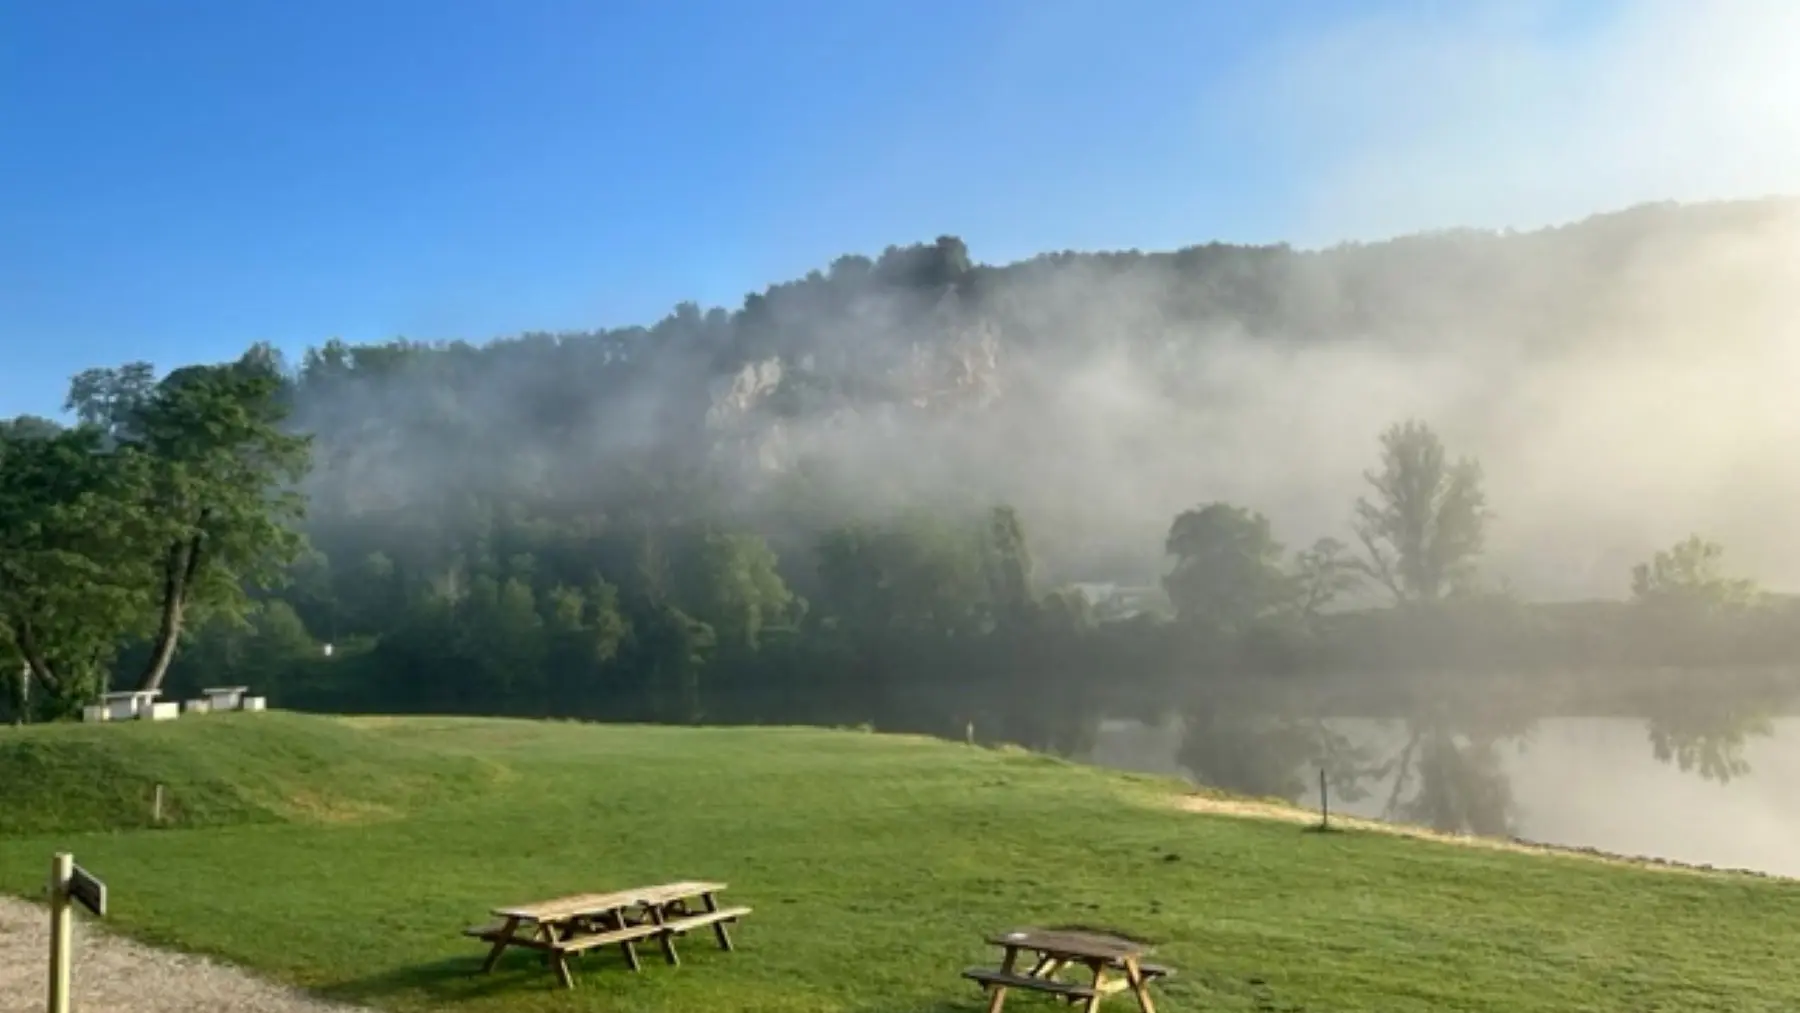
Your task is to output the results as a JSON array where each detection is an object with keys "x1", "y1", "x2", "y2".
[{"x1": 463, "y1": 882, "x2": 751, "y2": 988}]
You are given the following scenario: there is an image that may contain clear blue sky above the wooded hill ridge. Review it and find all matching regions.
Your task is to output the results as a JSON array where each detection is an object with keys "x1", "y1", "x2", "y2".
[{"x1": 10, "y1": 0, "x2": 1785, "y2": 416}]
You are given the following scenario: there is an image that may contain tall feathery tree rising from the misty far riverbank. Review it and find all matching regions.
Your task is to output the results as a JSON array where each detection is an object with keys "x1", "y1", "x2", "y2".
[{"x1": 1354, "y1": 421, "x2": 1489, "y2": 603}]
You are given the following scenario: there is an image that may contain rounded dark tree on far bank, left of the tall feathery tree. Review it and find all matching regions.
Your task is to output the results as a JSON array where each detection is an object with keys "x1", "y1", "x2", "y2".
[{"x1": 1163, "y1": 502, "x2": 1296, "y2": 635}]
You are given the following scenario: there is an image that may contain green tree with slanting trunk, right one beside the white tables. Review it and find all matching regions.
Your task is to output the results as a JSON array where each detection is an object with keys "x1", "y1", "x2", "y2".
[{"x1": 68, "y1": 349, "x2": 310, "y2": 689}]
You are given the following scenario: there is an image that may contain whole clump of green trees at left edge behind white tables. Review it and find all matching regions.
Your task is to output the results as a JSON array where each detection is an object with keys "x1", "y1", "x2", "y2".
[{"x1": 0, "y1": 347, "x2": 308, "y2": 714}]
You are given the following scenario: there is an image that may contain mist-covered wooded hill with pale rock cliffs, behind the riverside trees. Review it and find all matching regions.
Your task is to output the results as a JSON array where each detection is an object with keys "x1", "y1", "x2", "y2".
[{"x1": 295, "y1": 194, "x2": 1800, "y2": 597}]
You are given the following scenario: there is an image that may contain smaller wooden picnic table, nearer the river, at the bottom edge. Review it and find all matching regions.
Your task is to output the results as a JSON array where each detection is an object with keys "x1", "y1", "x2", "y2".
[{"x1": 963, "y1": 928, "x2": 1174, "y2": 1013}]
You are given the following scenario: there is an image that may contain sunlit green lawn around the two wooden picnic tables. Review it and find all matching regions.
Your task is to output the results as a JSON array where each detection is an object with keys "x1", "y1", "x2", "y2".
[{"x1": 0, "y1": 714, "x2": 1800, "y2": 1013}]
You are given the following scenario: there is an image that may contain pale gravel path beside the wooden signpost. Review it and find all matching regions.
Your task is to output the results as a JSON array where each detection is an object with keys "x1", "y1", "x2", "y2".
[{"x1": 0, "y1": 898, "x2": 358, "y2": 1013}]
